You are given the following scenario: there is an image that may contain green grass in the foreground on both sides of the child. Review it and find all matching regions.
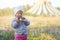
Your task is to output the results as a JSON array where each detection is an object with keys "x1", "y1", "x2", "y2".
[{"x1": 0, "y1": 27, "x2": 60, "y2": 40}]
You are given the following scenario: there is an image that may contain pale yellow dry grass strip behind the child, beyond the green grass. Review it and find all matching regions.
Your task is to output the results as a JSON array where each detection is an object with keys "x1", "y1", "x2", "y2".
[{"x1": 0, "y1": 16, "x2": 60, "y2": 27}]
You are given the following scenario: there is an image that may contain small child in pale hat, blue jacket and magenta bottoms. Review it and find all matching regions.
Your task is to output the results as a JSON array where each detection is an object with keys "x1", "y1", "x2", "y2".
[{"x1": 11, "y1": 6, "x2": 30, "y2": 40}]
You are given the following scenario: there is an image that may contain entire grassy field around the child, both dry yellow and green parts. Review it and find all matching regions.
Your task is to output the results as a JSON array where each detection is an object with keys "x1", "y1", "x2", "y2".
[{"x1": 0, "y1": 16, "x2": 60, "y2": 40}]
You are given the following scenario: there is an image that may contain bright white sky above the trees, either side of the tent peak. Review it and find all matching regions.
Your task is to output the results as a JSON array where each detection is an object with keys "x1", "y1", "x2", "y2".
[{"x1": 0, "y1": 0, "x2": 60, "y2": 8}]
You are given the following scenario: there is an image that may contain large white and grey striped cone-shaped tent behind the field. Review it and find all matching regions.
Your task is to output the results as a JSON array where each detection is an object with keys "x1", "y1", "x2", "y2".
[{"x1": 27, "y1": 0, "x2": 60, "y2": 16}]
